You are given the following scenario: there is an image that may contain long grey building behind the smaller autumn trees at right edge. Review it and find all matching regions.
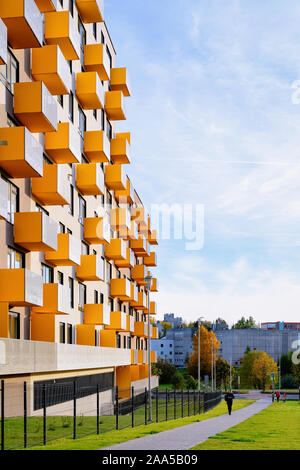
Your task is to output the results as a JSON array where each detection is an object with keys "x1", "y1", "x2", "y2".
[{"x1": 215, "y1": 328, "x2": 300, "y2": 366}]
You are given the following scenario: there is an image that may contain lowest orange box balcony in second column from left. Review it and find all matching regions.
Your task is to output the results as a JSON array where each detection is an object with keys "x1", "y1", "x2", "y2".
[{"x1": 32, "y1": 284, "x2": 71, "y2": 315}]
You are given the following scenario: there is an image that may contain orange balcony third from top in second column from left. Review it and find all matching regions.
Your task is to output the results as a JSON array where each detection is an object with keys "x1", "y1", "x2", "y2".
[{"x1": 45, "y1": 122, "x2": 81, "y2": 164}]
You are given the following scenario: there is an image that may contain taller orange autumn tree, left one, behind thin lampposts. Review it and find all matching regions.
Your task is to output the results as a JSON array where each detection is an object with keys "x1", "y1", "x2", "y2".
[{"x1": 187, "y1": 325, "x2": 220, "y2": 378}]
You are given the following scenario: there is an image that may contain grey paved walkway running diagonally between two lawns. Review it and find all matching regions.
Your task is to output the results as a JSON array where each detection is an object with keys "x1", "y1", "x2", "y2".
[{"x1": 100, "y1": 398, "x2": 272, "y2": 450}]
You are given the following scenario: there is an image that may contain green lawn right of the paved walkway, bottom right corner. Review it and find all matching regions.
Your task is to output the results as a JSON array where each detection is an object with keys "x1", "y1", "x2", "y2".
[{"x1": 193, "y1": 401, "x2": 300, "y2": 450}]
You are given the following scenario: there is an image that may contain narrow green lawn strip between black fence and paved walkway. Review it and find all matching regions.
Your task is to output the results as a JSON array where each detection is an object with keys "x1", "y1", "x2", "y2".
[{"x1": 16, "y1": 399, "x2": 255, "y2": 450}]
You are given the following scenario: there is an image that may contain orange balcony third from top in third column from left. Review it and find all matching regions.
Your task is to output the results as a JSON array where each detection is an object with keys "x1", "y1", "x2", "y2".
[{"x1": 76, "y1": 72, "x2": 104, "y2": 109}]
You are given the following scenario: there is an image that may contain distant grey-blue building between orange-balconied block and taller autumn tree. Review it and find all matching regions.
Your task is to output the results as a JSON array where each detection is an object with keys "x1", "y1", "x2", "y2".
[{"x1": 151, "y1": 328, "x2": 197, "y2": 369}]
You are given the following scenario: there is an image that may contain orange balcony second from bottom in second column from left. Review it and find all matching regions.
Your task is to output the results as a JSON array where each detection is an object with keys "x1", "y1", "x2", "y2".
[{"x1": 45, "y1": 233, "x2": 81, "y2": 266}]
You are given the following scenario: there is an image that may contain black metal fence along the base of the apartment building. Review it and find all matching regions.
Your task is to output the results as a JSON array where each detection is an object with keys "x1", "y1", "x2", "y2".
[{"x1": 0, "y1": 380, "x2": 221, "y2": 450}]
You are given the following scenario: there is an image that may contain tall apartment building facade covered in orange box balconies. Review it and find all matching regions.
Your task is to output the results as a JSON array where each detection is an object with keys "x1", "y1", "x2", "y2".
[{"x1": 0, "y1": 0, "x2": 157, "y2": 412}]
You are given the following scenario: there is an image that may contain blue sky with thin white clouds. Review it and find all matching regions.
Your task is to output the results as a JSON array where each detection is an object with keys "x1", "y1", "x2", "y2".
[{"x1": 105, "y1": 0, "x2": 300, "y2": 324}]
